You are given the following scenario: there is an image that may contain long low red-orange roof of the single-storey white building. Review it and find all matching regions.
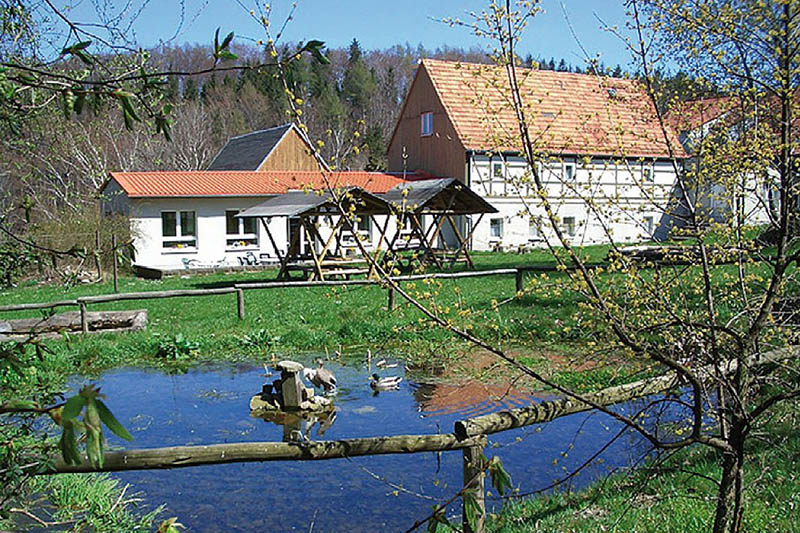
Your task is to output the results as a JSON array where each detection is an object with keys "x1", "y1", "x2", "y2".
[{"x1": 111, "y1": 170, "x2": 424, "y2": 198}]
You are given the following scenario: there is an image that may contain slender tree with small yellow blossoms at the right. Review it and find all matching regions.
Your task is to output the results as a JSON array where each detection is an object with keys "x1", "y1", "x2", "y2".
[{"x1": 432, "y1": 0, "x2": 800, "y2": 533}]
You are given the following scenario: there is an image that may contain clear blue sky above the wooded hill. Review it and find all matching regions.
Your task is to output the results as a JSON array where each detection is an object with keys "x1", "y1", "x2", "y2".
[{"x1": 61, "y1": 0, "x2": 630, "y2": 66}]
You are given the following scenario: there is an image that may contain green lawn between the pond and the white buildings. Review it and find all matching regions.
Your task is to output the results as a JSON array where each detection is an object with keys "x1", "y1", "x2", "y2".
[{"x1": 0, "y1": 247, "x2": 607, "y2": 372}]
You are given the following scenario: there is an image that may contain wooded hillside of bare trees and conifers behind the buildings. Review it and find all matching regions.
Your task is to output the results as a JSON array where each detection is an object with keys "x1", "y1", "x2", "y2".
[{"x1": 0, "y1": 38, "x2": 698, "y2": 255}]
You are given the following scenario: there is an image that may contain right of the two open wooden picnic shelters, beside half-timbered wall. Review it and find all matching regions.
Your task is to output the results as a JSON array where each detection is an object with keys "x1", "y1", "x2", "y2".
[{"x1": 380, "y1": 178, "x2": 497, "y2": 270}]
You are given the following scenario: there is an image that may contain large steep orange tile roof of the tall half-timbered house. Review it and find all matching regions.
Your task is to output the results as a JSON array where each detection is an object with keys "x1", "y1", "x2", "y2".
[{"x1": 421, "y1": 59, "x2": 686, "y2": 157}]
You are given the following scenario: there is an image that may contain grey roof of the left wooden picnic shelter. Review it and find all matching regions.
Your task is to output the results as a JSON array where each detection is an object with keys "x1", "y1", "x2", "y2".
[{"x1": 237, "y1": 187, "x2": 390, "y2": 217}]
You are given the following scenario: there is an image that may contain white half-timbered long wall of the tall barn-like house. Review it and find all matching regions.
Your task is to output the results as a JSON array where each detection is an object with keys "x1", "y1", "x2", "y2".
[{"x1": 468, "y1": 155, "x2": 676, "y2": 250}]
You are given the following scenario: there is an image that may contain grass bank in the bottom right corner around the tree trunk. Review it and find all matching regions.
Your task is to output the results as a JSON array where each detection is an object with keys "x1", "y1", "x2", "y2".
[{"x1": 487, "y1": 405, "x2": 800, "y2": 533}]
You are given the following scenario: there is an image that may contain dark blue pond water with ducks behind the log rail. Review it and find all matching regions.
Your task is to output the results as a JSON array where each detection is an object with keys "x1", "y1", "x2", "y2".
[{"x1": 75, "y1": 357, "x2": 664, "y2": 533}]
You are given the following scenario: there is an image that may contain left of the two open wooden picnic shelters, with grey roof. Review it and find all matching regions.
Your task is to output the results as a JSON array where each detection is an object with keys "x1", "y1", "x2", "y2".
[{"x1": 238, "y1": 187, "x2": 391, "y2": 280}]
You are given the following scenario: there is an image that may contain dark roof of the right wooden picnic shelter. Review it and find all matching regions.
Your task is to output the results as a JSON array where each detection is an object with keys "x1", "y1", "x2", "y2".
[{"x1": 380, "y1": 178, "x2": 497, "y2": 215}]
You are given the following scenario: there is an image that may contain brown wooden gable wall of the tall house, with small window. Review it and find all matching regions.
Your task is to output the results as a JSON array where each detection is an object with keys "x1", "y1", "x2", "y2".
[{"x1": 388, "y1": 66, "x2": 466, "y2": 181}]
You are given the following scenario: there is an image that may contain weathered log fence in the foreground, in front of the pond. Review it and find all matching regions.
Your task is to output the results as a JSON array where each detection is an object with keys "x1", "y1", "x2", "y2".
[{"x1": 42, "y1": 347, "x2": 800, "y2": 533}]
